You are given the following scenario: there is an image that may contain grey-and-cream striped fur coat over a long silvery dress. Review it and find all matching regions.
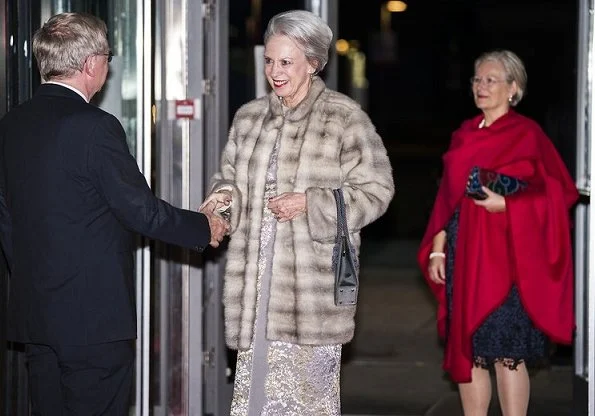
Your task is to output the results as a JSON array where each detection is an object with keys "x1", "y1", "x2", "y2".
[{"x1": 211, "y1": 77, "x2": 394, "y2": 349}]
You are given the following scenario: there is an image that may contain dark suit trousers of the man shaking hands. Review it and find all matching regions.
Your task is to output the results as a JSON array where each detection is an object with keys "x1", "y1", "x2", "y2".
[{"x1": 25, "y1": 340, "x2": 134, "y2": 416}]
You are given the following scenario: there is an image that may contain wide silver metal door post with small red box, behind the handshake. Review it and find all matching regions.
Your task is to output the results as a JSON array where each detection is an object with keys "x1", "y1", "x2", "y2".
[{"x1": 152, "y1": 0, "x2": 218, "y2": 416}]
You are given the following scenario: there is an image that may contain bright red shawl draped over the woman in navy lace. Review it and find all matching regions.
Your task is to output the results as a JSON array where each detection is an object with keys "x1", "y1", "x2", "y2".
[{"x1": 418, "y1": 111, "x2": 578, "y2": 383}]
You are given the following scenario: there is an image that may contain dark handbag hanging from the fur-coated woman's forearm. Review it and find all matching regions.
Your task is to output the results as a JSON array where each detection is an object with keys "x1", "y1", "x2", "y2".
[{"x1": 332, "y1": 189, "x2": 359, "y2": 306}]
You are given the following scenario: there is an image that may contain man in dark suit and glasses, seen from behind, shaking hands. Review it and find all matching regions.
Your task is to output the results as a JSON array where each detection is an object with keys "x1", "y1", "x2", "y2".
[{"x1": 0, "y1": 13, "x2": 229, "y2": 416}]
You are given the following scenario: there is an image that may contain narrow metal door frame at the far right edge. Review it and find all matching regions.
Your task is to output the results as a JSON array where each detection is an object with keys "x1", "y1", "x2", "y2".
[{"x1": 573, "y1": 0, "x2": 595, "y2": 416}]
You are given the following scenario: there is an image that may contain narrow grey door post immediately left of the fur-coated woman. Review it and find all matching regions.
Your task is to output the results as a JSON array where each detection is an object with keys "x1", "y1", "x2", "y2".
[{"x1": 203, "y1": 0, "x2": 233, "y2": 416}]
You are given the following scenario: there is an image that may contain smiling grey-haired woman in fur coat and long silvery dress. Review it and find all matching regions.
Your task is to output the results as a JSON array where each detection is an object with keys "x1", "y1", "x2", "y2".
[{"x1": 203, "y1": 10, "x2": 394, "y2": 416}]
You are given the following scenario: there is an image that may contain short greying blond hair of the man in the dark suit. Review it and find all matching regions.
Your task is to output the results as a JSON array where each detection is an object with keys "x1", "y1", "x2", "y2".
[{"x1": 33, "y1": 13, "x2": 109, "y2": 80}]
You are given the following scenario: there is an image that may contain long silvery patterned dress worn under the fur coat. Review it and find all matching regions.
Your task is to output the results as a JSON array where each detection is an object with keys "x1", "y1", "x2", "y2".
[{"x1": 230, "y1": 131, "x2": 341, "y2": 416}]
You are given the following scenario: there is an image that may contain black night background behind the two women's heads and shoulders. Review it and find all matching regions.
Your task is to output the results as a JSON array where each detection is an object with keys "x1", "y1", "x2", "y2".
[{"x1": 230, "y1": 0, "x2": 578, "y2": 240}]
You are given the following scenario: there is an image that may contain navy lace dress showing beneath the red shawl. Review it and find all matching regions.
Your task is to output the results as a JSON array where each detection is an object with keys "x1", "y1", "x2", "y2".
[{"x1": 446, "y1": 210, "x2": 548, "y2": 369}]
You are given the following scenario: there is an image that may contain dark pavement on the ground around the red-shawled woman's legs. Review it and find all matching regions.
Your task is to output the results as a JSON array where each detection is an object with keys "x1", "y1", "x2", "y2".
[{"x1": 341, "y1": 242, "x2": 573, "y2": 416}]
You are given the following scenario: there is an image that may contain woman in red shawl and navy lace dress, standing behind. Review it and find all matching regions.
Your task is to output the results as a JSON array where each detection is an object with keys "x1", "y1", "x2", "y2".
[{"x1": 418, "y1": 51, "x2": 578, "y2": 416}]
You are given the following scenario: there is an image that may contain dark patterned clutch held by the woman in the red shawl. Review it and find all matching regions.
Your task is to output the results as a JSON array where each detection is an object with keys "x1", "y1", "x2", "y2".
[{"x1": 465, "y1": 166, "x2": 527, "y2": 199}]
